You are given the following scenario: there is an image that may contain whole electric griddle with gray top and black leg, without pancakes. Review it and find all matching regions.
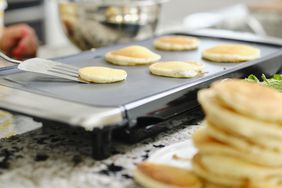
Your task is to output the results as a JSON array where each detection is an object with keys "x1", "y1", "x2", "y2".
[{"x1": 0, "y1": 33, "x2": 282, "y2": 158}]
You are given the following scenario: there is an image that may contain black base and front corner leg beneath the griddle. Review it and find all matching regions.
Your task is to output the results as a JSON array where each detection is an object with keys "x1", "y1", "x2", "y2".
[{"x1": 39, "y1": 107, "x2": 203, "y2": 160}]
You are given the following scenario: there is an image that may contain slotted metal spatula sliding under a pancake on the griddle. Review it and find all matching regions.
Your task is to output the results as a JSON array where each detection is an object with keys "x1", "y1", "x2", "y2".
[{"x1": 0, "y1": 52, "x2": 88, "y2": 83}]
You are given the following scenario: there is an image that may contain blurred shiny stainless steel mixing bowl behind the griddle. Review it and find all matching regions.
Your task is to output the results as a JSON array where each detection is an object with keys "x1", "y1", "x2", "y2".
[{"x1": 58, "y1": 0, "x2": 164, "y2": 50}]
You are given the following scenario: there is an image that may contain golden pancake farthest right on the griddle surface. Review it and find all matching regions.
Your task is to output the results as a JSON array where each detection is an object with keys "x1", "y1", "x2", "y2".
[{"x1": 202, "y1": 44, "x2": 260, "y2": 63}]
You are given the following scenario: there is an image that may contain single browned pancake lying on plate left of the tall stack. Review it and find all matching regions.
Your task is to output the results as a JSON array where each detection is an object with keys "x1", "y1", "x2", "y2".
[{"x1": 134, "y1": 162, "x2": 202, "y2": 188}]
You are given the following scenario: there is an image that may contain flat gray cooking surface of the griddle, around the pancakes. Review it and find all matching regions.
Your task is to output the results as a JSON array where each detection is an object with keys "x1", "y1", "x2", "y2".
[{"x1": 0, "y1": 37, "x2": 279, "y2": 106}]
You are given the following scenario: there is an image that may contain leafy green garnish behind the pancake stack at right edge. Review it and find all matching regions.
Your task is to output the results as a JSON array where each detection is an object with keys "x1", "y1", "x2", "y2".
[{"x1": 245, "y1": 74, "x2": 282, "y2": 92}]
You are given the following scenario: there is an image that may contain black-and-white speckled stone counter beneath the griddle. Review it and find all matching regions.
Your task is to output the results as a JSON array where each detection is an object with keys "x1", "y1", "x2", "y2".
[{"x1": 0, "y1": 117, "x2": 198, "y2": 188}]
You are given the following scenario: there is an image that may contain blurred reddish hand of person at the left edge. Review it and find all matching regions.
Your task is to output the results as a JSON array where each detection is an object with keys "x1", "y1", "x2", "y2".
[{"x1": 0, "y1": 0, "x2": 38, "y2": 59}]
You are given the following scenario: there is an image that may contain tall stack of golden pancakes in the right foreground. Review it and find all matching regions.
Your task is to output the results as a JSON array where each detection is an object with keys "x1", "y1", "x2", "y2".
[{"x1": 192, "y1": 80, "x2": 282, "y2": 188}]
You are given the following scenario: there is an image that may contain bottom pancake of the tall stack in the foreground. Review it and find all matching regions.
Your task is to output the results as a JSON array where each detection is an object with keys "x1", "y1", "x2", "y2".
[{"x1": 192, "y1": 153, "x2": 280, "y2": 188}]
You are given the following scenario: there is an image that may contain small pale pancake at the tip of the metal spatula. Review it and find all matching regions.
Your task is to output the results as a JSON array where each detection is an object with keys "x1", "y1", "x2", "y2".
[{"x1": 79, "y1": 67, "x2": 127, "y2": 83}]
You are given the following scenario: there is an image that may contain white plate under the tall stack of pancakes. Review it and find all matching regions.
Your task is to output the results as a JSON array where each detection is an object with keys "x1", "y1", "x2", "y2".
[{"x1": 148, "y1": 140, "x2": 197, "y2": 169}]
